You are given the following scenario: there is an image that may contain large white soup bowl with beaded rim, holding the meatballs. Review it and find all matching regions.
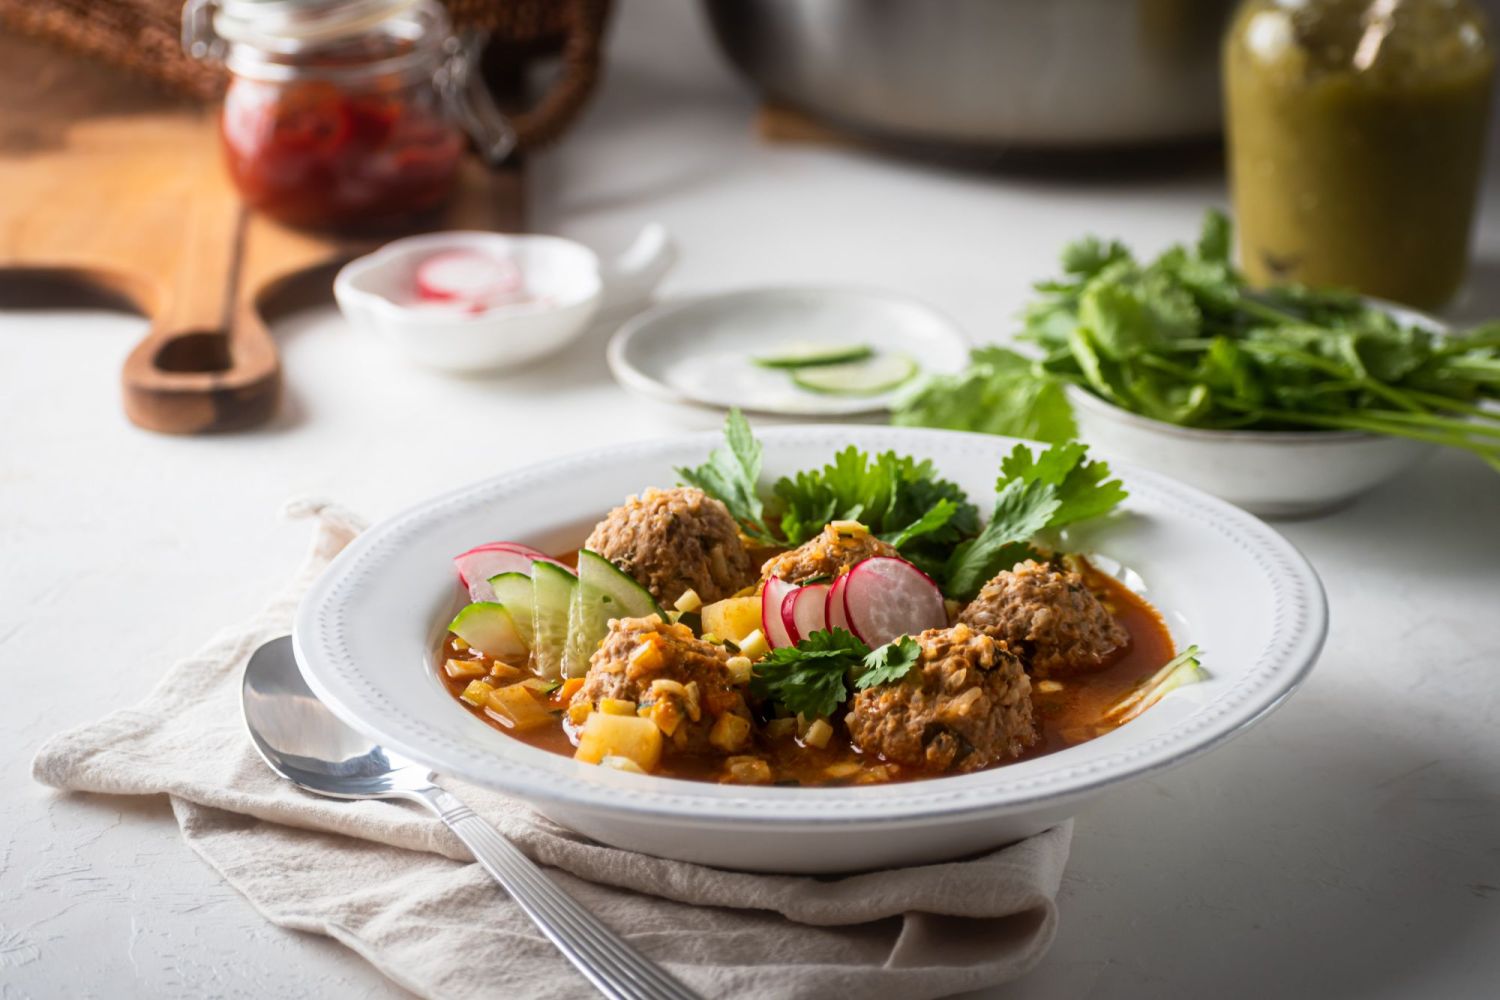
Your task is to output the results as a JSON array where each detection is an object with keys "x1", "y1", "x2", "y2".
[{"x1": 294, "y1": 426, "x2": 1328, "y2": 873}]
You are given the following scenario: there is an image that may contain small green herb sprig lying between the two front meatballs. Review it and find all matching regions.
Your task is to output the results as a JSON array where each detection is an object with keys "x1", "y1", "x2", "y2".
[{"x1": 750, "y1": 628, "x2": 921, "y2": 718}]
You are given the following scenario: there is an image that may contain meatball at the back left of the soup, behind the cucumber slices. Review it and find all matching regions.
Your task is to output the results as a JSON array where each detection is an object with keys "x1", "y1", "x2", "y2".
[{"x1": 584, "y1": 486, "x2": 755, "y2": 604}]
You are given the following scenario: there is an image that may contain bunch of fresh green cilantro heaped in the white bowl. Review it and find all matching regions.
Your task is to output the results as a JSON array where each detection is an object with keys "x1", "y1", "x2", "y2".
[{"x1": 894, "y1": 211, "x2": 1500, "y2": 469}]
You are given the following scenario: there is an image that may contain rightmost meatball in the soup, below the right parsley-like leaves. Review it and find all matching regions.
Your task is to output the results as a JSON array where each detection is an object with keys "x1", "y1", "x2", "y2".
[{"x1": 959, "y1": 559, "x2": 1130, "y2": 678}]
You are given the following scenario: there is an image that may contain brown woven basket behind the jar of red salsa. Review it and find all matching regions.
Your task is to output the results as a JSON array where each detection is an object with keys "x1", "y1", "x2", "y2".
[{"x1": 0, "y1": 0, "x2": 611, "y2": 148}]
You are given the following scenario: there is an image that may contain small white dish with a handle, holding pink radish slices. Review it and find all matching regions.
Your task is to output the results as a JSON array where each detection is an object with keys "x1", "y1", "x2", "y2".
[{"x1": 333, "y1": 223, "x2": 677, "y2": 372}]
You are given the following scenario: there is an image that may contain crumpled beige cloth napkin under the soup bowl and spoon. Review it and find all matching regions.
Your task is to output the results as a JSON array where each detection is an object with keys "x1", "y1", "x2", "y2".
[{"x1": 35, "y1": 502, "x2": 1073, "y2": 1000}]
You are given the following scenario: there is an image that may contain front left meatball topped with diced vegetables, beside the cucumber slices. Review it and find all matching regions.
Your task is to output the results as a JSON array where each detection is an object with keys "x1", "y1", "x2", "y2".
[{"x1": 572, "y1": 615, "x2": 750, "y2": 753}]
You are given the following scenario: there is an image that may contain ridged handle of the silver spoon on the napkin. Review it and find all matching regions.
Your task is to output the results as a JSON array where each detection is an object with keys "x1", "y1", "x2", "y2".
[{"x1": 414, "y1": 786, "x2": 699, "y2": 1000}]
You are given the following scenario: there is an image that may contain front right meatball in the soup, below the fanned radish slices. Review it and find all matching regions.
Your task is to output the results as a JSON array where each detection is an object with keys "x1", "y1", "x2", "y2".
[{"x1": 845, "y1": 625, "x2": 1037, "y2": 772}]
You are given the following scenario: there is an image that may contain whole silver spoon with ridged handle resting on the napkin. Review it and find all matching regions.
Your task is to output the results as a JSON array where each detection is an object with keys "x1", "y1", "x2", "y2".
[{"x1": 240, "y1": 636, "x2": 698, "y2": 1000}]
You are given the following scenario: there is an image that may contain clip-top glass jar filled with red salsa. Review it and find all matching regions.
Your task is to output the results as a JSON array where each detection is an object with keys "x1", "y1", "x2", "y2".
[{"x1": 183, "y1": 0, "x2": 513, "y2": 228}]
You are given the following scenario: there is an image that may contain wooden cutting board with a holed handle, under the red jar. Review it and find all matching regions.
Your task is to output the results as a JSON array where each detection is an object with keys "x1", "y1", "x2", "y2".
[{"x1": 0, "y1": 36, "x2": 524, "y2": 433}]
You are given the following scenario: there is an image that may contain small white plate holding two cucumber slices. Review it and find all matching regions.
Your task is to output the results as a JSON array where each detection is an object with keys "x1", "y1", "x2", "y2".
[{"x1": 608, "y1": 288, "x2": 969, "y2": 417}]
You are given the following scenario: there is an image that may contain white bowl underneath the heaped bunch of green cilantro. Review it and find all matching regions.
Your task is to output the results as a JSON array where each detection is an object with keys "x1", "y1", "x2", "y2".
[{"x1": 1068, "y1": 298, "x2": 1448, "y2": 517}]
